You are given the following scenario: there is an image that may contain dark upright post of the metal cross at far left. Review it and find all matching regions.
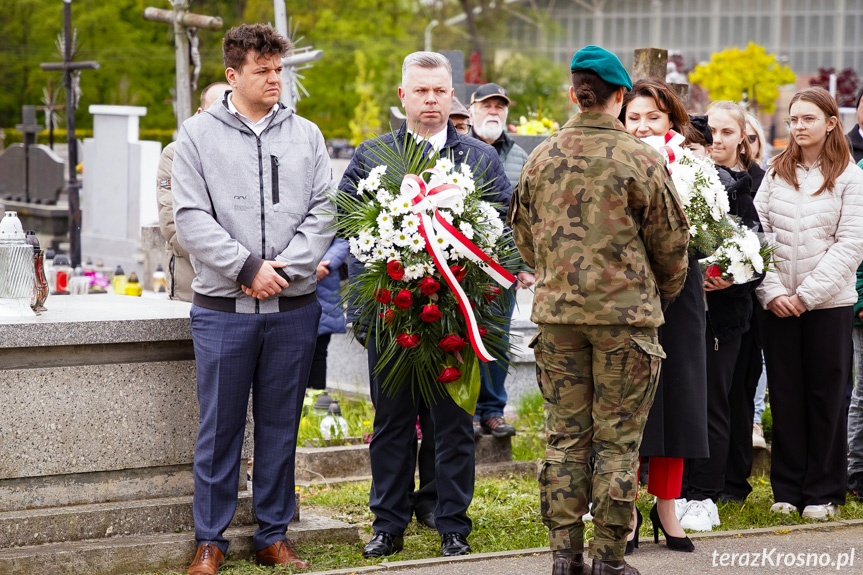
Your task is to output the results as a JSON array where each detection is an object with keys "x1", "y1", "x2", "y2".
[{"x1": 63, "y1": 0, "x2": 81, "y2": 269}]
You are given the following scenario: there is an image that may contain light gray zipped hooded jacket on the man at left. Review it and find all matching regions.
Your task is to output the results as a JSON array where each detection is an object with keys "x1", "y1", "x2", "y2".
[{"x1": 172, "y1": 92, "x2": 335, "y2": 313}]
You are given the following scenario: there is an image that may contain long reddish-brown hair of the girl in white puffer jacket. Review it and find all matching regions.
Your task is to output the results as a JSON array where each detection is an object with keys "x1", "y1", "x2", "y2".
[{"x1": 770, "y1": 88, "x2": 851, "y2": 196}]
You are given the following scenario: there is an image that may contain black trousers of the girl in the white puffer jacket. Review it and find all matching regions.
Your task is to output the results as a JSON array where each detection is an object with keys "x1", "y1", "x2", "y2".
[{"x1": 757, "y1": 306, "x2": 853, "y2": 508}]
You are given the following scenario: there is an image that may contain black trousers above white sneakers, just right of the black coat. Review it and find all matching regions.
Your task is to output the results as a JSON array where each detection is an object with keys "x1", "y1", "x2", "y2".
[{"x1": 680, "y1": 321, "x2": 752, "y2": 501}]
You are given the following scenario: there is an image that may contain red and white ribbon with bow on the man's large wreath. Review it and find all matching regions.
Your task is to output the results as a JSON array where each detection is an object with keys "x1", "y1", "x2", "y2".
[{"x1": 401, "y1": 170, "x2": 515, "y2": 361}]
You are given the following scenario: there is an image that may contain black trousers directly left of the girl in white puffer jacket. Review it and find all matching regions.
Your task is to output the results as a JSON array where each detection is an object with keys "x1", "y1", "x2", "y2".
[{"x1": 722, "y1": 317, "x2": 763, "y2": 501}]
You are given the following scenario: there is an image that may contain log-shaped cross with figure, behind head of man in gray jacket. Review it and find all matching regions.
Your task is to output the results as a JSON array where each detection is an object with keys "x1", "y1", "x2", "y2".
[{"x1": 144, "y1": 0, "x2": 222, "y2": 131}]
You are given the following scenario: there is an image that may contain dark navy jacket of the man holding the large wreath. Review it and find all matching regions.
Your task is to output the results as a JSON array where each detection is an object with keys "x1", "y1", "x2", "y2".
[{"x1": 339, "y1": 122, "x2": 512, "y2": 341}]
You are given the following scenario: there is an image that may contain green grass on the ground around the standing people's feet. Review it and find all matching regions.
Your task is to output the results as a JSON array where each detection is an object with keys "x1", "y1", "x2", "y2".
[{"x1": 133, "y1": 392, "x2": 863, "y2": 575}]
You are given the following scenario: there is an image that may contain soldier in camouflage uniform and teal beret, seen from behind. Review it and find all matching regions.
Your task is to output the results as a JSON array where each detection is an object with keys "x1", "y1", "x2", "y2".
[{"x1": 509, "y1": 46, "x2": 689, "y2": 575}]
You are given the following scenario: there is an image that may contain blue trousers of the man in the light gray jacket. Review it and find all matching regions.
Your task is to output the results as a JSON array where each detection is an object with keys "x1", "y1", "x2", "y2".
[{"x1": 190, "y1": 301, "x2": 321, "y2": 553}]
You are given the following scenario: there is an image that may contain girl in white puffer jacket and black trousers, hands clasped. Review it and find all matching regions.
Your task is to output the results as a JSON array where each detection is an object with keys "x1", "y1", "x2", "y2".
[{"x1": 755, "y1": 88, "x2": 863, "y2": 519}]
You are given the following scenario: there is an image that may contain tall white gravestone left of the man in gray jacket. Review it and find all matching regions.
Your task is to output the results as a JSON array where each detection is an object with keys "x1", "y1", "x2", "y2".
[{"x1": 81, "y1": 106, "x2": 162, "y2": 273}]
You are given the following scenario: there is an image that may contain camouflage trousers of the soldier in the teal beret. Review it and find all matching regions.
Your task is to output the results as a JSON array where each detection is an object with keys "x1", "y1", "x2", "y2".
[{"x1": 530, "y1": 324, "x2": 665, "y2": 560}]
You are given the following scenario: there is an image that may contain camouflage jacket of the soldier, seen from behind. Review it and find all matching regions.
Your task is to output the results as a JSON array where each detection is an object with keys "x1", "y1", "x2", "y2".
[{"x1": 509, "y1": 113, "x2": 689, "y2": 327}]
